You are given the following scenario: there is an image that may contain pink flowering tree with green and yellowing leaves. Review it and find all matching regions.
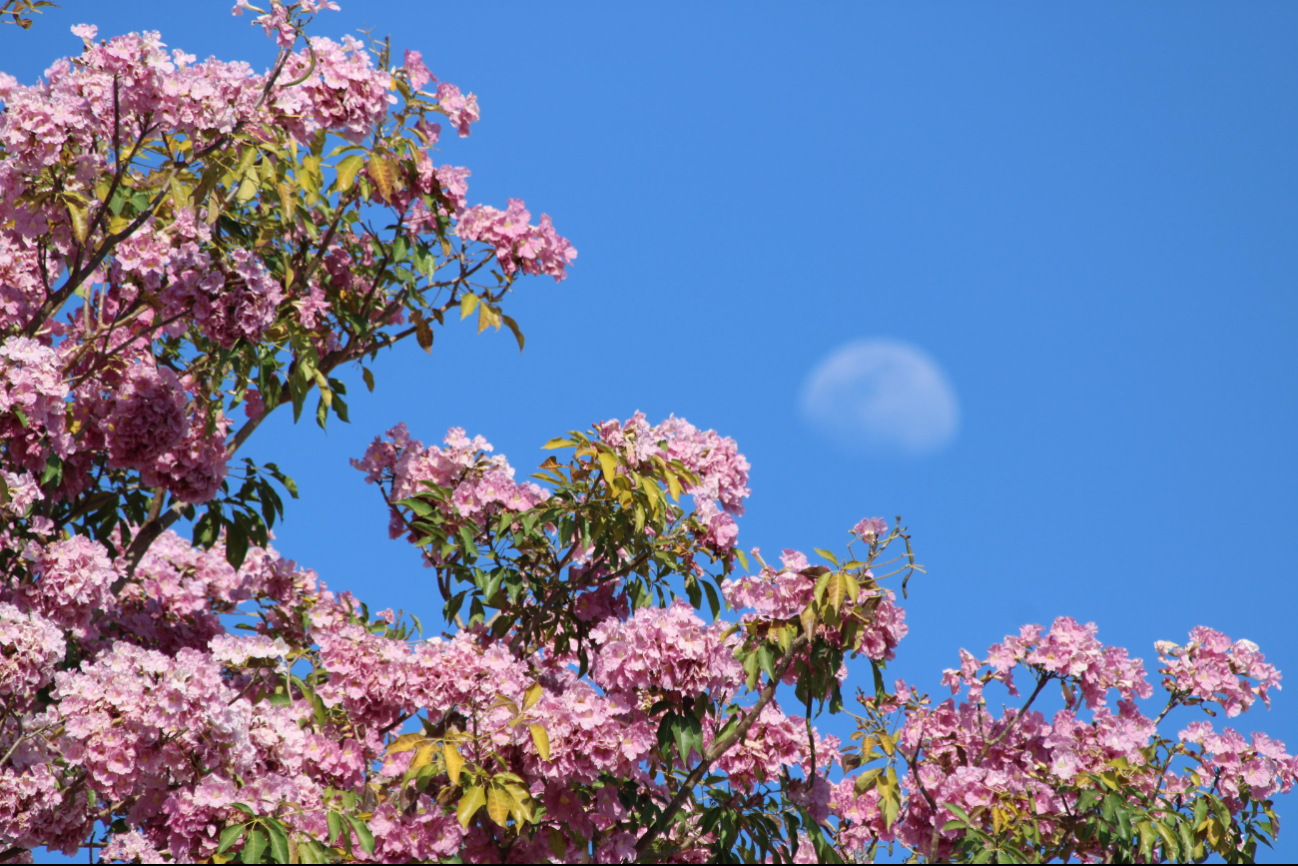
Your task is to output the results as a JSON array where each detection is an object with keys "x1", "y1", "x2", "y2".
[{"x1": 0, "y1": 0, "x2": 1298, "y2": 863}]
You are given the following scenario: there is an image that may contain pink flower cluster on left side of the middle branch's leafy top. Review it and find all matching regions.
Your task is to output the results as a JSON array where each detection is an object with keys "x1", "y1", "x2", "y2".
[{"x1": 352, "y1": 423, "x2": 549, "y2": 538}]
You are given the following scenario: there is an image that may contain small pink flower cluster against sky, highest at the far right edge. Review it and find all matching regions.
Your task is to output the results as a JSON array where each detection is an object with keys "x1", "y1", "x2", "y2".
[{"x1": 1154, "y1": 626, "x2": 1280, "y2": 717}]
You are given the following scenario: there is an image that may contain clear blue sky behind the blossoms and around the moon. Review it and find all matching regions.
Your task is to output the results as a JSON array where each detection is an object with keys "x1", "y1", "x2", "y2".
[{"x1": 0, "y1": 0, "x2": 1298, "y2": 861}]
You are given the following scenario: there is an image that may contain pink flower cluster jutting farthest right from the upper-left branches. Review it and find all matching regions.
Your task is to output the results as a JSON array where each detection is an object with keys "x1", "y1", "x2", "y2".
[{"x1": 456, "y1": 198, "x2": 576, "y2": 283}]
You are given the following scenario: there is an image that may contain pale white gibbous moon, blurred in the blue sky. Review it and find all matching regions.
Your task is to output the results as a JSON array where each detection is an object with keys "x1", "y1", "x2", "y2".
[{"x1": 801, "y1": 340, "x2": 961, "y2": 454}]
